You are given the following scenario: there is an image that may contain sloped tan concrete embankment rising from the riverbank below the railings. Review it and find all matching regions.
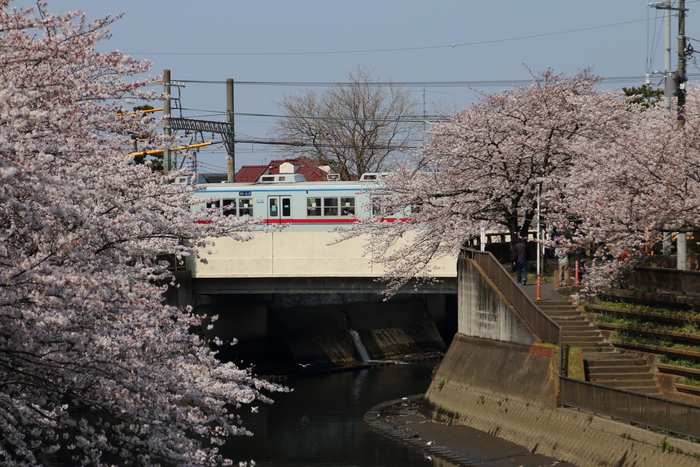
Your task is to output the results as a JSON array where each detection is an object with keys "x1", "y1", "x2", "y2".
[{"x1": 420, "y1": 335, "x2": 700, "y2": 467}]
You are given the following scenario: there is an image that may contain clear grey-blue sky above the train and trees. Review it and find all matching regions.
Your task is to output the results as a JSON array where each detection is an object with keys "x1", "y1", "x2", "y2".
[{"x1": 9, "y1": 0, "x2": 700, "y2": 172}]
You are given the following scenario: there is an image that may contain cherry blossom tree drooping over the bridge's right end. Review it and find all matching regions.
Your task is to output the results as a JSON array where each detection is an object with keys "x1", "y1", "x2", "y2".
[{"x1": 342, "y1": 70, "x2": 631, "y2": 293}]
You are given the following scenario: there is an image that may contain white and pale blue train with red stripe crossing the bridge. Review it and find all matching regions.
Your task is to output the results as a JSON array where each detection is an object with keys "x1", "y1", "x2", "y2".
[{"x1": 183, "y1": 174, "x2": 393, "y2": 231}]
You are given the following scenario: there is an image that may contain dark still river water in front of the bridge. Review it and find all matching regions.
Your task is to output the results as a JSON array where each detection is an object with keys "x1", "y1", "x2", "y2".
[{"x1": 222, "y1": 360, "x2": 438, "y2": 467}]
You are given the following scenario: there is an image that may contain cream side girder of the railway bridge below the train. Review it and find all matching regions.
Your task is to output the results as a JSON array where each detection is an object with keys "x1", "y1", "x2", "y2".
[{"x1": 188, "y1": 230, "x2": 457, "y2": 294}]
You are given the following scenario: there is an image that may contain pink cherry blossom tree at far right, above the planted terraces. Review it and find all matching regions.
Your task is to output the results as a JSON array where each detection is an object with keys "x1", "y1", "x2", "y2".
[{"x1": 547, "y1": 87, "x2": 700, "y2": 293}]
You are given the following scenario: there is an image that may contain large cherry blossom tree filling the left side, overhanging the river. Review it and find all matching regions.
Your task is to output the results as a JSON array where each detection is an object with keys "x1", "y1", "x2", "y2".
[{"x1": 0, "y1": 0, "x2": 284, "y2": 466}]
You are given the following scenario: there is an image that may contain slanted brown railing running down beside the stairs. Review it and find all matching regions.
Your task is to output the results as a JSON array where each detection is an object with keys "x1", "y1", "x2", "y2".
[{"x1": 462, "y1": 248, "x2": 561, "y2": 348}]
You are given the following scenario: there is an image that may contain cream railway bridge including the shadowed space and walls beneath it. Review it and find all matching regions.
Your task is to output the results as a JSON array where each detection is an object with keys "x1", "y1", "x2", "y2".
[{"x1": 176, "y1": 230, "x2": 457, "y2": 364}]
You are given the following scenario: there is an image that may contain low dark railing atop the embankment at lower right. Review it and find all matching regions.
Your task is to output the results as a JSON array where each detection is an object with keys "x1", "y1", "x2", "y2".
[{"x1": 560, "y1": 376, "x2": 700, "y2": 438}]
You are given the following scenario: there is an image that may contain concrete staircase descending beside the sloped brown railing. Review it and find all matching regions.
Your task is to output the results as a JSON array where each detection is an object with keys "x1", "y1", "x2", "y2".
[{"x1": 537, "y1": 301, "x2": 661, "y2": 395}]
